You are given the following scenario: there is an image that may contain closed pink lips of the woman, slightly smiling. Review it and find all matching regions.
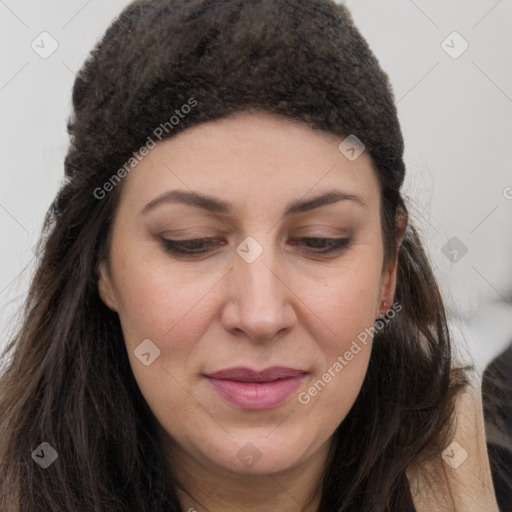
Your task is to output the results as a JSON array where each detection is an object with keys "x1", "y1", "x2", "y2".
[{"x1": 205, "y1": 366, "x2": 307, "y2": 409}]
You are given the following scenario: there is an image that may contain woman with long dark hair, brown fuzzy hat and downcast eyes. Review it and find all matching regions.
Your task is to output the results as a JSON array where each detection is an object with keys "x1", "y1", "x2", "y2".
[{"x1": 0, "y1": 0, "x2": 497, "y2": 512}]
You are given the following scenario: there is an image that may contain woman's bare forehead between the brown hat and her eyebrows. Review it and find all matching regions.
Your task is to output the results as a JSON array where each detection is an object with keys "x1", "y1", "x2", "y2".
[{"x1": 116, "y1": 112, "x2": 379, "y2": 218}]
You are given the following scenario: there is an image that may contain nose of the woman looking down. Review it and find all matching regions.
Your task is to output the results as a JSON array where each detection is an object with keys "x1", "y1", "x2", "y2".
[{"x1": 222, "y1": 239, "x2": 297, "y2": 341}]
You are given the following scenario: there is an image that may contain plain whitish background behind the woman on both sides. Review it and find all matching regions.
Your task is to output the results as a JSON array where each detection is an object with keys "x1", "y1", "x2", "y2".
[{"x1": 0, "y1": 0, "x2": 512, "y2": 371}]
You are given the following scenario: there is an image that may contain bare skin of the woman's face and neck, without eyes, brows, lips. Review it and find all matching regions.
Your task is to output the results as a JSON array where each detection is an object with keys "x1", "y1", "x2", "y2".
[{"x1": 99, "y1": 112, "x2": 406, "y2": 512}]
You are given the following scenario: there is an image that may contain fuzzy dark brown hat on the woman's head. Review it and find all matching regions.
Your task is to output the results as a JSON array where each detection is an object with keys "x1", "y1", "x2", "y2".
[{"x1": 65, "y1": 0, "x2": 405, "y2": 206}]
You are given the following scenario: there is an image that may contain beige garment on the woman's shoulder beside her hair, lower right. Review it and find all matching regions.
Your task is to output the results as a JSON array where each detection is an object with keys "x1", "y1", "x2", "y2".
[{"x1": 407, "y1": 381, "x2": 499, "y2": 512}]
